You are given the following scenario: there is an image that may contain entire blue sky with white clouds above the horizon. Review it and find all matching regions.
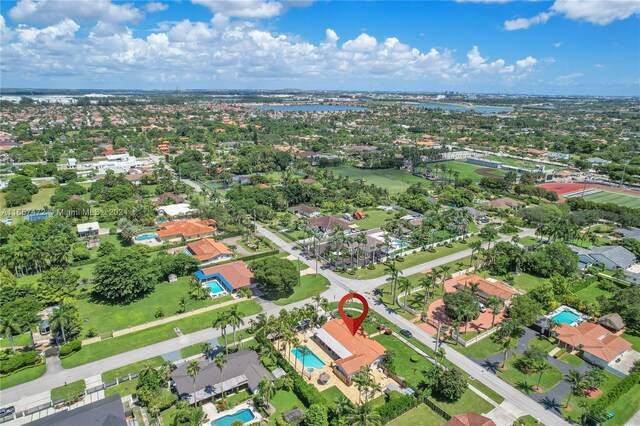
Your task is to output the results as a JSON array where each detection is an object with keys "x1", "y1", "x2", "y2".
[{"x1": 0, "y1": 0, "x2": 640, "y2": 96}]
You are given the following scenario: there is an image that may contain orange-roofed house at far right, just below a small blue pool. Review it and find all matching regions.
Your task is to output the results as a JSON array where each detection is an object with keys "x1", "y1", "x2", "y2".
[{"x1": 554, "y1": 322, "x2": 631, "y2": 370}]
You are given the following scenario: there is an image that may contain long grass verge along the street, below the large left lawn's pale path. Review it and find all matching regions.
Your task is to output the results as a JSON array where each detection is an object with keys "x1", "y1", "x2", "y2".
[{"x1": 62, "y1": 300, "x2": 262, "y2": 368}]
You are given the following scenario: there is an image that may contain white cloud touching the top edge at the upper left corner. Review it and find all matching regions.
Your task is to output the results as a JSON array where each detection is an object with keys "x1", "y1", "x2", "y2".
[{"x1": 9, "y1": 0, "x2": 143, "y2": 25}]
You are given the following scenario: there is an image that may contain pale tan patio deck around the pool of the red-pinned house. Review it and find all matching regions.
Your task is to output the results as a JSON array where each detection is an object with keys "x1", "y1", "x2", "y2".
[{"x1": 278, "y1": 330, "x2": 397, "y2": 403}]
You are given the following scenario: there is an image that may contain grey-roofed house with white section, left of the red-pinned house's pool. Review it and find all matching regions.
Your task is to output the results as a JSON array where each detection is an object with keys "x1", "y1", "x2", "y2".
[{"x1": 171, "y1": 349, "x2": 274, "y2": 404}]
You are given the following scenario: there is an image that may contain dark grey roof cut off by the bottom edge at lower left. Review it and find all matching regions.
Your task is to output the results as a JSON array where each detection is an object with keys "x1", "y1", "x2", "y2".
[{"x1": 27, "y1": 395, "x2": 128, "y2": 426}]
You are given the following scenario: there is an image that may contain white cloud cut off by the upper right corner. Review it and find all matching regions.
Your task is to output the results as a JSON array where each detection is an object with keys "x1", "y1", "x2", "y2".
[{"x1": 551, "y1": 0, "x2": 640, "y2": 25}]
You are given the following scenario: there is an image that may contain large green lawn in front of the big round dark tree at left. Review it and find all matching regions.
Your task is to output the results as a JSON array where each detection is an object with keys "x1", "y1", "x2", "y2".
[{"x1": 78, "y1": 276, "x2": 231, "y2": 334}]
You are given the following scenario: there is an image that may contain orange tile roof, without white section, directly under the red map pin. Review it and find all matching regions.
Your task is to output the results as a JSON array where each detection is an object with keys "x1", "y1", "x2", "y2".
[{"x1": 322, "y1": 319, "x2": 387, "y2": 375}]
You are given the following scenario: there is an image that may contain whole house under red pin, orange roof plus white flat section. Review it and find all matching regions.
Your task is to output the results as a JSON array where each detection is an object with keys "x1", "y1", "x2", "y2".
[{"x1": 314, "y1": 319, "x2": 386, "y2": 385}]
